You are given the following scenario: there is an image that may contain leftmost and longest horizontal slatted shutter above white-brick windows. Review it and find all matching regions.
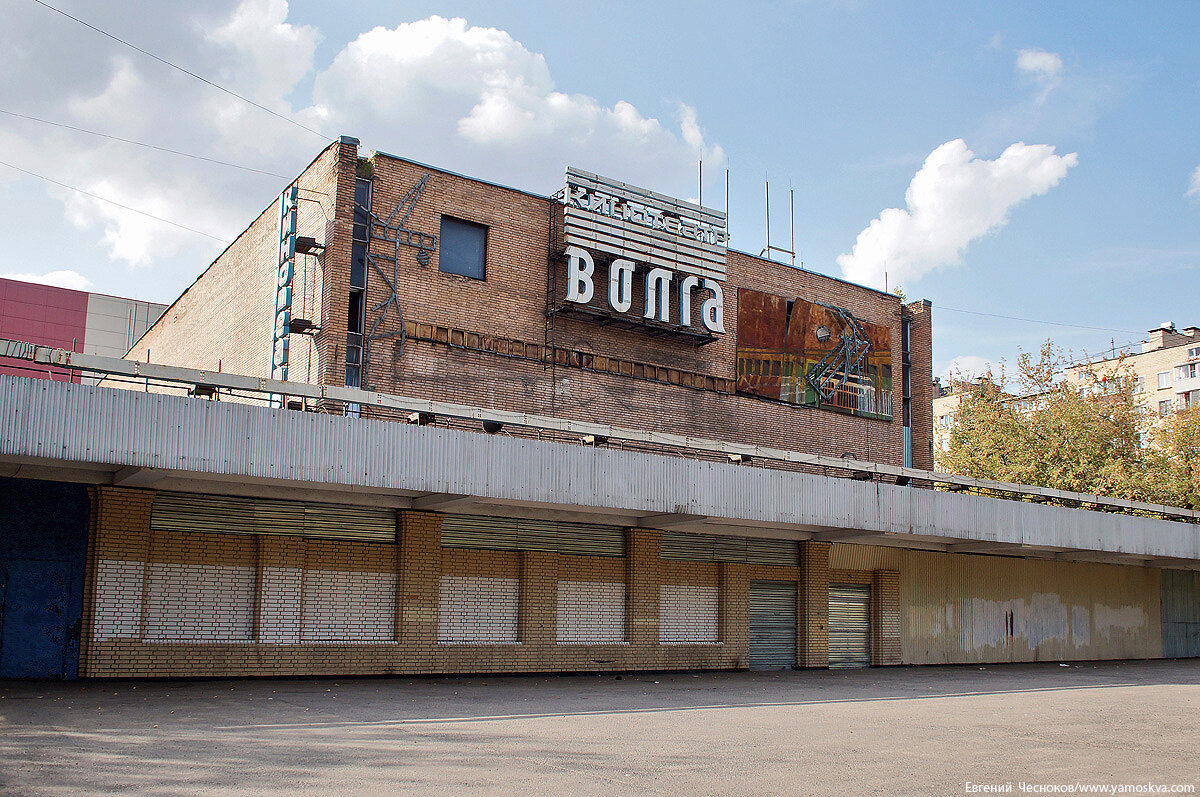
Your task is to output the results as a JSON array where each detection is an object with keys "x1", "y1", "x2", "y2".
[{"x1": 150, "y1": 492, "x2": 396, "y2": 543}]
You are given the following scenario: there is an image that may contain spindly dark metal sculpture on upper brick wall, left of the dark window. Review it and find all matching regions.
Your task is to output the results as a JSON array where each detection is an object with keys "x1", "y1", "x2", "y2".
[{"x1": 358, "y1": 174, "x2": 438, "y2": 386}]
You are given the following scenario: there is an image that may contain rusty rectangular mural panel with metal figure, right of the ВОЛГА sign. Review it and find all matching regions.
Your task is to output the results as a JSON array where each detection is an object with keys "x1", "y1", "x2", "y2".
[{"x1": 738, "y1": 288, "x2": 892, "y2": 418}]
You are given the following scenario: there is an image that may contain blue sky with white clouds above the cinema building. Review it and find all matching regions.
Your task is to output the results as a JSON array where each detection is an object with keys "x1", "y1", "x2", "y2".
[{"x1": 0, "y1": 0, "x2": 1200, "y2": 376}]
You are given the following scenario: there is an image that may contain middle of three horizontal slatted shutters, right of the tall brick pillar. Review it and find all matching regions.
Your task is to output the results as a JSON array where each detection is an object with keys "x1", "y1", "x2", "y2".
[{"x1": 442, "y1": 515, "x2": 625, "y2": 558}]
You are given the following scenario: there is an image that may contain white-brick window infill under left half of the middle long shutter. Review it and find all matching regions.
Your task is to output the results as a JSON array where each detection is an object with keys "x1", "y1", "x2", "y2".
[{"x1": 438, "y1": 575, "x2": 520, "y2": 643}]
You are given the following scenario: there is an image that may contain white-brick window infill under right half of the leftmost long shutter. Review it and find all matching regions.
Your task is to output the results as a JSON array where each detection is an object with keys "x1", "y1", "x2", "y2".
[{"x1": 300, "y1": 570, "x2": 396, "y2": 645}]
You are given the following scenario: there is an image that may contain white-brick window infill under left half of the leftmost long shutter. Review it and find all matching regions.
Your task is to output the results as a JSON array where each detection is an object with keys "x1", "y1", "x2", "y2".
[{"x1": 144, "y1": 562, "x2": 256, "y2": 642}]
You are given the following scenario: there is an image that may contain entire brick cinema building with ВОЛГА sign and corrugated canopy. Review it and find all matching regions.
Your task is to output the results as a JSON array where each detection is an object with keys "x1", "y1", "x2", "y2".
[{"x1": 0, "y1": 138, "x2": 1200, "y2": 677}]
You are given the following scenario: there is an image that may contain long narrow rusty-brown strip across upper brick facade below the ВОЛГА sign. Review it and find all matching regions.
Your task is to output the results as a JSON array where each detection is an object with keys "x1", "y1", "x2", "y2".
[{"x1": 404, "y1": 320, "x2": 737, "y2": 394}]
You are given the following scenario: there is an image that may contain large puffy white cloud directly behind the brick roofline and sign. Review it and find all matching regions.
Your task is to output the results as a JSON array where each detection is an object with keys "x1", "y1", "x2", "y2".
[{"x1": 313, "y1": 16, "x2": 725, "y2": 196}]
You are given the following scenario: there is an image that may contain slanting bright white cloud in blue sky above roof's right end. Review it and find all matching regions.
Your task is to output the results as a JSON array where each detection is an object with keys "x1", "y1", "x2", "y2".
[{"x1": 838, "y1": 139, "x2": 1079, "y2": 287}]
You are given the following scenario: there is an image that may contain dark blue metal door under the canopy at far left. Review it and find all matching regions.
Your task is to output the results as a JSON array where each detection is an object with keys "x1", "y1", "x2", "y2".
[{"x1": 0, "y1": 559, "x2": 73, "y2": 678}]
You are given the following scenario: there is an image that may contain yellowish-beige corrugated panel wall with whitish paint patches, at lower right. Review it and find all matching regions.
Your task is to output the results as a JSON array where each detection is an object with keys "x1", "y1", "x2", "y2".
[{"x1": 900, "y1": 551, "x2": 1163, "y2": 664}]
